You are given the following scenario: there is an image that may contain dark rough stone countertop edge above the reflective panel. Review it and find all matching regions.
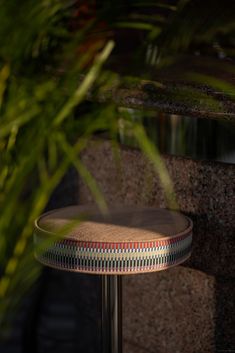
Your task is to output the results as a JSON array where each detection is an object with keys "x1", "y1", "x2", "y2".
[{"x1": 87, "y1": 78, "x2": 235, "y2": 122}]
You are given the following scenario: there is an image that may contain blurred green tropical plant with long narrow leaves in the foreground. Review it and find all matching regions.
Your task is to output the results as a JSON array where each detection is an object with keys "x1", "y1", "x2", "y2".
[{"x1": 0, "y1": 0, "x2": 235, "y2": 336}]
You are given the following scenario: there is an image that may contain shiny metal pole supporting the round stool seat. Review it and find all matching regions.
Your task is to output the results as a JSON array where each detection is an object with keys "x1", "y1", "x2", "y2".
[{"x1": 101, "y1": 275, "x2": 122, "y2": 353}]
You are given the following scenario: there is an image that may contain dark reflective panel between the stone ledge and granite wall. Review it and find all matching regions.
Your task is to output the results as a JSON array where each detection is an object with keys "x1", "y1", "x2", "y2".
[{"x1": 120, "y1": 108, "x2": 235, "y2": 164}]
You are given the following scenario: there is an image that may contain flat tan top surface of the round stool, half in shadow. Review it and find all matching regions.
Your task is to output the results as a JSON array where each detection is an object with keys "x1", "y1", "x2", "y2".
[{"x1": 36, "y1": 205, "x2": 192, "y2": 243}]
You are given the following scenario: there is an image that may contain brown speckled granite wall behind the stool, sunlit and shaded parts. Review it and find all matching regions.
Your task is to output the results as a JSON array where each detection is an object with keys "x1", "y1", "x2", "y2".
[{"x1": 80, "y1": 141, "x2": 235, "y2": 353}]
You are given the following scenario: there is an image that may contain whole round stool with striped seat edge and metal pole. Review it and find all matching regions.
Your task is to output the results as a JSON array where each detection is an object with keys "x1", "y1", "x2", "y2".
[{"x1": 34, "y1": 205, "x2": 192, "y2": 353}]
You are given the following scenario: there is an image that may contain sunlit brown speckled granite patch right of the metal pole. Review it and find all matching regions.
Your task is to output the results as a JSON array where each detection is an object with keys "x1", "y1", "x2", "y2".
[{"x1": 123, "y1": 266, "x2": 215, "y2": 353}]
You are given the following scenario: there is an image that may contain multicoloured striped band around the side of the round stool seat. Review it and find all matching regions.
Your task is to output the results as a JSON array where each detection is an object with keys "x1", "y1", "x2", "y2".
[{"x1": 35, "y1": 233, "x2": 192, "y2": 274}]
